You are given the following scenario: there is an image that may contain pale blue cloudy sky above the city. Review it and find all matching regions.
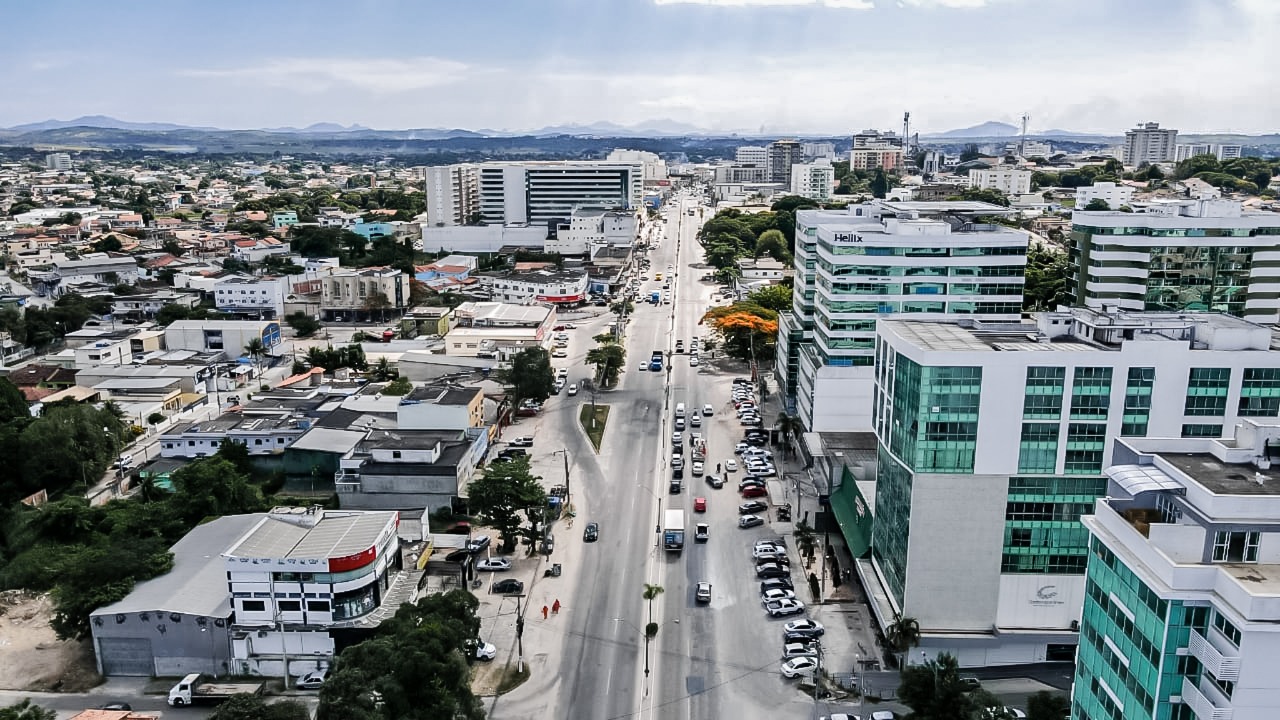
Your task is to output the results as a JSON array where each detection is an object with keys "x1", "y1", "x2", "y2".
[{"x1": 0, "y1": 0, "x2": 1280, "y2": 135}]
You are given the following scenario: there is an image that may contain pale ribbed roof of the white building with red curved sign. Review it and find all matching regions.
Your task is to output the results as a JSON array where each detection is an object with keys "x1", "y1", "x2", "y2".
[{"x1": 221, "y1": 507, "x2": 397, "y2": 561}]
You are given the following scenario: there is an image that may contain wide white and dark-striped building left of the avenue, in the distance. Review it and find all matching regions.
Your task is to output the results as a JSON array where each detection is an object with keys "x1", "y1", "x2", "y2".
[{"x1": 425, "y1": 160, "x2": 644, "y2": 227}]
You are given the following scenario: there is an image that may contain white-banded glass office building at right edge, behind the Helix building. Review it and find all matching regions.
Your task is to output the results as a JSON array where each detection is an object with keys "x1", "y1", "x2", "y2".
[{"x1": 1069, "y1": 199, "x2": 1280, "y2": 323}]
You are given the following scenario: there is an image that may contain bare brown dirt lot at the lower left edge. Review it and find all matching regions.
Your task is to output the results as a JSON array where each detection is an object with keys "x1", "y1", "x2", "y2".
[{"x1": 0, "y1": 591, "x2": 102, "y2": 692}]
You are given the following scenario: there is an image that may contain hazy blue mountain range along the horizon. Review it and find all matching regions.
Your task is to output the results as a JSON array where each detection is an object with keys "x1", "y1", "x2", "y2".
[{"x1": 0, "y1": 115, "x2": 1270, "y2": 142}]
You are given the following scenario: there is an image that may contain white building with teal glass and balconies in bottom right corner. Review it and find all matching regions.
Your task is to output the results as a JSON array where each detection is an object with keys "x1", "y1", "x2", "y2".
[{"x1": 1071, "y1": 420, "x2": 1280, "y2": 720}]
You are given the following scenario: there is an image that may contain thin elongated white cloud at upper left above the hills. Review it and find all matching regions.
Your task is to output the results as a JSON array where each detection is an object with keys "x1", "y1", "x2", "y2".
[{"x1": 178, "y1": 56, "x2": 471, "y2": 94}]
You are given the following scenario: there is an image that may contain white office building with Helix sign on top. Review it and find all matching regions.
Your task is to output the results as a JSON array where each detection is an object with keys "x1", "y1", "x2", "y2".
[{"x1": 776, "y1": 201, "x2": 1028, "y2": 432}]
